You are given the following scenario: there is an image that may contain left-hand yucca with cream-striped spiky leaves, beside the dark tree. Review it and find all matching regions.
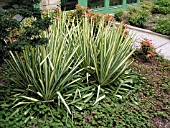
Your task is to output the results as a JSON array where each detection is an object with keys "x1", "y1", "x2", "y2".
[{"x1": 8, "y1": 13, "x2": 83, "y2": 113}]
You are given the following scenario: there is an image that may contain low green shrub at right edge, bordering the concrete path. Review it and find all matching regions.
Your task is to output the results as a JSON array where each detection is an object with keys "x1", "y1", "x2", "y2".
[{"x1": 153, "y1": 16, "x2": 170, "y2": 36}]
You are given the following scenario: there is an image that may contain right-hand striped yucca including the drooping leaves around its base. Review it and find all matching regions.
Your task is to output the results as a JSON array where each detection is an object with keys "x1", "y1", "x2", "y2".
[{"x1": 62, "y1": 17, "x2": 134, "y2": 104}]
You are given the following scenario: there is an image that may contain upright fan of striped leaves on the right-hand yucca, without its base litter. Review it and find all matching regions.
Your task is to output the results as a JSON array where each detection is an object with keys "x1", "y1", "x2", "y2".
[{"x1": 72, "y1": 18, "x2": 134, "y2": 87}]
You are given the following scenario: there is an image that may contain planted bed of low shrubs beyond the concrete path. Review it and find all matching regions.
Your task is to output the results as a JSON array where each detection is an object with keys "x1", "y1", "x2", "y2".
[{"x1": 115, "y1": 0, "x2": 170, "y2": 36}]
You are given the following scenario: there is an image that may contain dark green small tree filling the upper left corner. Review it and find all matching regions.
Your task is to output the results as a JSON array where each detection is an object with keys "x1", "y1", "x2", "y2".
[{"x1": 0, "y1": 0, "x2": 51, "y2": 62}]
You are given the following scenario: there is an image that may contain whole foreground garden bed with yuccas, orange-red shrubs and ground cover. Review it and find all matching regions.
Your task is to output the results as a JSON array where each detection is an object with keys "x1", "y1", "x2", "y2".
[{"x1": 0, "y1": 1, "x2": 170, "y2": 128}]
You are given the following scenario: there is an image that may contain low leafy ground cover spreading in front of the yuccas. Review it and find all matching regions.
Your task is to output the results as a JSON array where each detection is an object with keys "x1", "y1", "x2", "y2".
[{"x1": 0, "y1": 54, "x2": 170, "y2": 128}]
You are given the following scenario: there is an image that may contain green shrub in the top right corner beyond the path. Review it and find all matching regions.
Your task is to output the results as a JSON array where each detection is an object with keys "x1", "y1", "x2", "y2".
[{"x1": 152, "y1": 0, "x2": 170, "y2": 14}]
